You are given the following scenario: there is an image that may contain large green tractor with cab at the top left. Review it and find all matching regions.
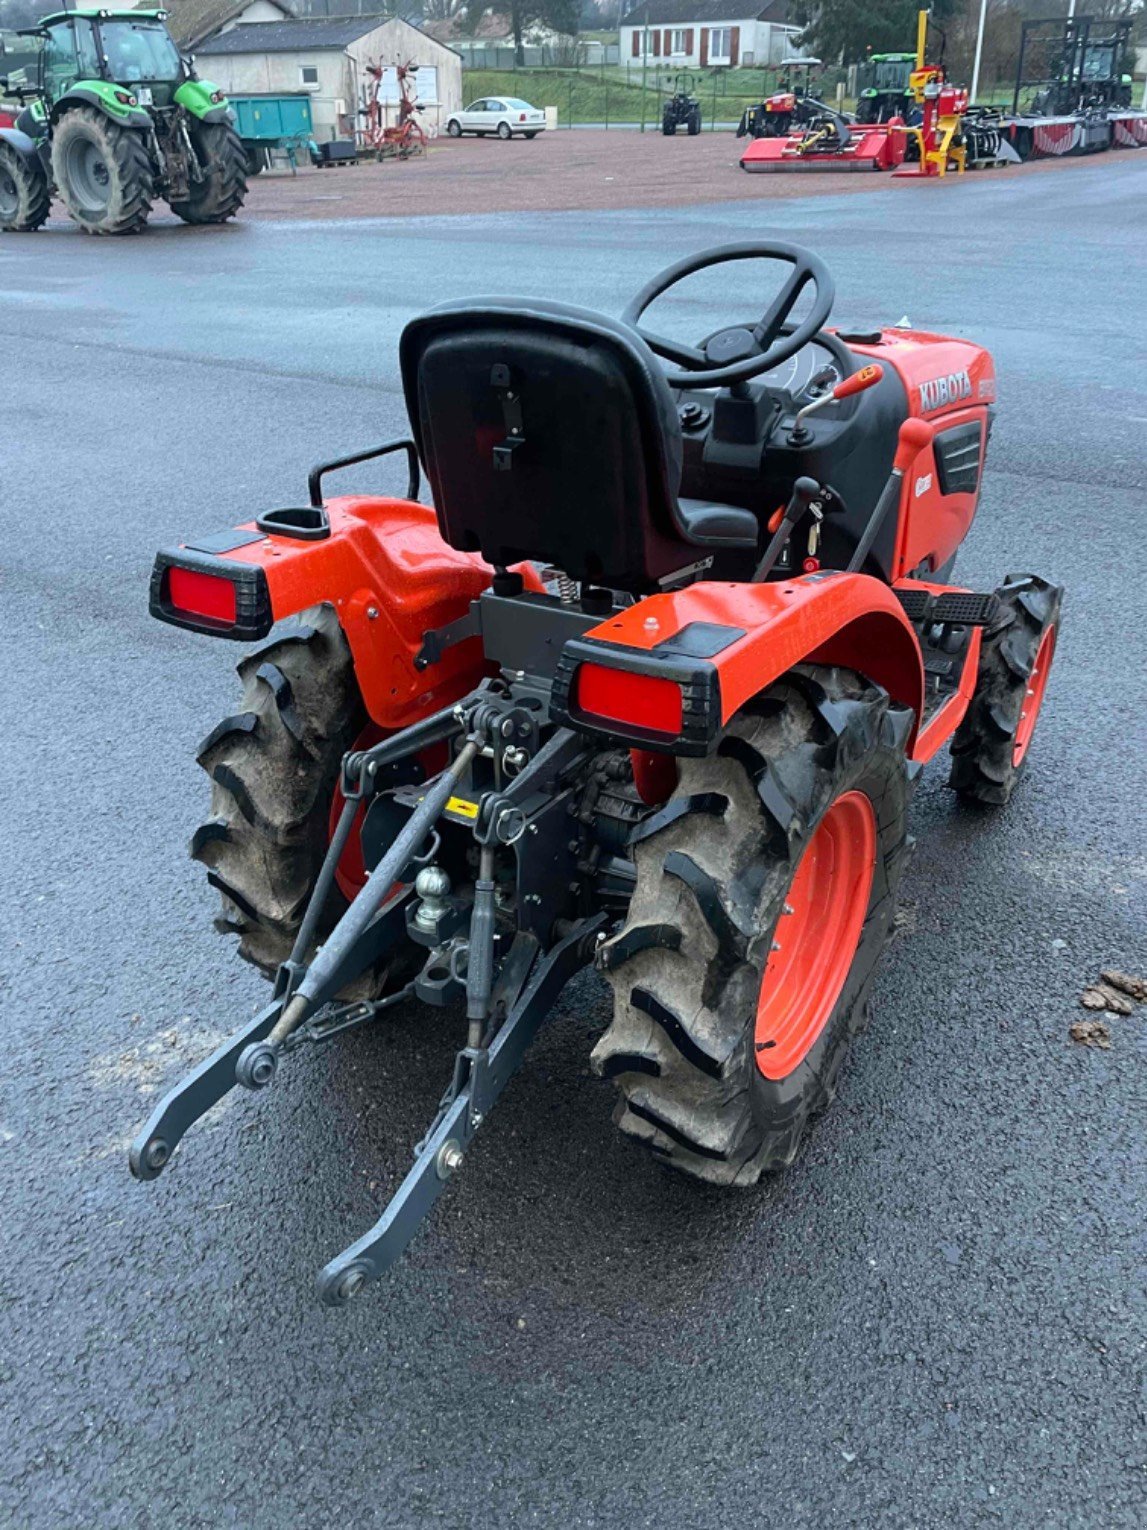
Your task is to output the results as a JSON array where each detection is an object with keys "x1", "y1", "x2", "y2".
[{"x1": 0, "y1": 11, "x2": 246, "y2": 234}]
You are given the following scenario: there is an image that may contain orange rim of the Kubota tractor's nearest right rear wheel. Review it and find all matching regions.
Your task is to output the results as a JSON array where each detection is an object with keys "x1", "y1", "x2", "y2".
[{"x1": 755, "y1": 791, "x2": 876, "y2": 1079}]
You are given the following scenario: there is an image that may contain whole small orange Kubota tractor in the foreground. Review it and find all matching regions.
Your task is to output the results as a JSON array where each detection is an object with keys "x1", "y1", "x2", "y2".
[{"x1": 130, "y1": 243, "x2": 1061, "y2": 1305}]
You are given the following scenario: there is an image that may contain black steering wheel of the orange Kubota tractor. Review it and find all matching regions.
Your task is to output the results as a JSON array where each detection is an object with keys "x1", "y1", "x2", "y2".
[{"x1": 621, "y1": 242, "x2": 837, "y2": 387}]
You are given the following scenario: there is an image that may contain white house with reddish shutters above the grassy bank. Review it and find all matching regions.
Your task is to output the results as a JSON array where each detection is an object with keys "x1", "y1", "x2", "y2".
[{"x1": 621, "y1": 0, "x2": 801, "y2": 69}]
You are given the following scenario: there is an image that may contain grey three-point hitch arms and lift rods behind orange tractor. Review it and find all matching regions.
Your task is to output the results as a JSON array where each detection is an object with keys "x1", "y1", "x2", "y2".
[{"x1": 128, "y1": 702, "x2": 609, "y2": 1307}]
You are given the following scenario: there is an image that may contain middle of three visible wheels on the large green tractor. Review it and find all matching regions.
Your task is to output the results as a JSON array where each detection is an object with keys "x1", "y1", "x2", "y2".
[{"x1": 52, "y1": 106, "x2": 154, "y2": 234}]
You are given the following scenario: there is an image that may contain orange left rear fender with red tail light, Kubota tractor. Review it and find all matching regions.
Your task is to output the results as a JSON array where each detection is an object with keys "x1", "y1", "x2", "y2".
[{"x1": 150, "y1": 496, "x2": 541, "y2": 728}]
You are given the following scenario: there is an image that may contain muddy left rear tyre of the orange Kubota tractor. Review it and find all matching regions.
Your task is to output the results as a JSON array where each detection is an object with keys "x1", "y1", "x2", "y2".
[{"x1": 191, "y1": 606, "x2": 383, "y2": 976}]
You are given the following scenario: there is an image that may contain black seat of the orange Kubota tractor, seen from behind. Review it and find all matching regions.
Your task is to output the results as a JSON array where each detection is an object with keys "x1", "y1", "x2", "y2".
[{"x1": 399, "y1": 298, "x2": 759, "y2": 595}]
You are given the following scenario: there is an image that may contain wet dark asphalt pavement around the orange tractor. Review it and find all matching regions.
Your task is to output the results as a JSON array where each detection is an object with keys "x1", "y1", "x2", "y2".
[{"x1": 0, "y1": 153, "x2": 1147, "y2": 1530}]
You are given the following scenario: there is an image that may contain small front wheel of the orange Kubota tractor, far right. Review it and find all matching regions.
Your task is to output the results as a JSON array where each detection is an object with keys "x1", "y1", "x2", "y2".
[{"x1": 948, "y1": 574, "x2": 1063, "y2": 806}]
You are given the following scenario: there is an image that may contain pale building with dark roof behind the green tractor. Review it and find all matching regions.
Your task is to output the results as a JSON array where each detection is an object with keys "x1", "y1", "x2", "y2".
[{"x1": 196, "y1": 15, "x2": 462, "y2": 142}]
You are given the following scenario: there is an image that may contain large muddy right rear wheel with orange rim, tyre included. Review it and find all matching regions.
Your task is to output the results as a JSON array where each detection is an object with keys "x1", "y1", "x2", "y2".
[{"x1": 592, "y1": 667, "x2": 911, "y2": 1184}]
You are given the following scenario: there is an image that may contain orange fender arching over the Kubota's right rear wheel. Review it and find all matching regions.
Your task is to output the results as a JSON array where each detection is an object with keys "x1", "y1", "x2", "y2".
[{"x1": 580, "y1": 571, "x2": 924, "y2": 742}]
